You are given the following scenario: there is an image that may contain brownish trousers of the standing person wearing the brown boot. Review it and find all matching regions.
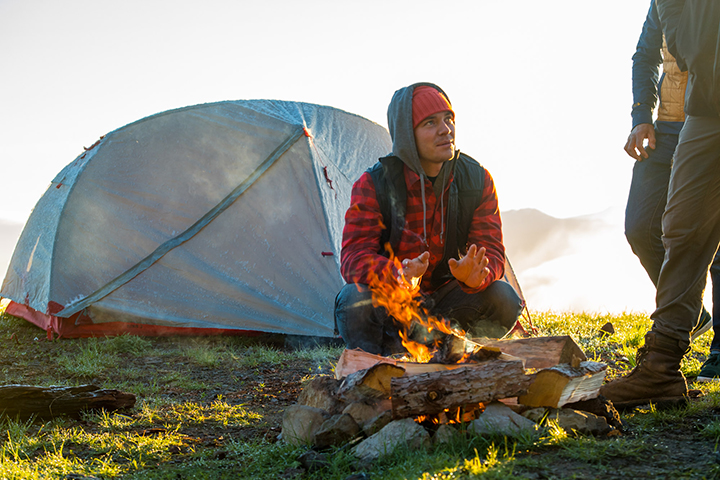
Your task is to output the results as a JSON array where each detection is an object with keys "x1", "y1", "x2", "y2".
[{"x1": 652, "y1": 116, "x2": 720, "y2": 348}]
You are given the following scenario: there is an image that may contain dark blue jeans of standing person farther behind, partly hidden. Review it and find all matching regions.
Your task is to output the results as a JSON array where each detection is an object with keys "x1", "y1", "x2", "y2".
[{"x1": 625, "y1": 131, "x2": 720, "y2": 349}]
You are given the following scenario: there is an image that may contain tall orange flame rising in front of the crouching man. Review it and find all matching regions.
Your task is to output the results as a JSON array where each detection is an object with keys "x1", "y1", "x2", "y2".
[{"x1": 369, "y1": 244, "x2": 465, "y2": 363}]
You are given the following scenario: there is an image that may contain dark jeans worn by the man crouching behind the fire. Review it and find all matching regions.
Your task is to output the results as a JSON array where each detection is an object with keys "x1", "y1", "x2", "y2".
[{"x1": 335, "y1": 280, "x2": 522, "y2": 355}]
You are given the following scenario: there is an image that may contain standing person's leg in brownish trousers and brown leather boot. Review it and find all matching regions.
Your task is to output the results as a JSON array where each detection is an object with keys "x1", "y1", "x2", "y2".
[{"x1": 600, "y1": 116, "x2": 720, "y2": 402}]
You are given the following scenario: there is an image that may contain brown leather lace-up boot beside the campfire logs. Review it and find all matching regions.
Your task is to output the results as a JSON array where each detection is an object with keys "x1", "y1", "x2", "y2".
[{"x1": 600, "y1": 332, "x2": 688, "y2": 406}]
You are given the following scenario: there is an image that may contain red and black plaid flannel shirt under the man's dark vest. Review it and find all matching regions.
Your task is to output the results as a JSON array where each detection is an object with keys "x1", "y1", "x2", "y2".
[{"x1": 340, "y1": 166, "x2": 505, "y2": 294}]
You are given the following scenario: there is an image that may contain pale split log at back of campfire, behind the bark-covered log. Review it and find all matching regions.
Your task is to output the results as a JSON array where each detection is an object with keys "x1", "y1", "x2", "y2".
[{"x1": 477, "y1": 335, "x2": 587, "y2": 369}]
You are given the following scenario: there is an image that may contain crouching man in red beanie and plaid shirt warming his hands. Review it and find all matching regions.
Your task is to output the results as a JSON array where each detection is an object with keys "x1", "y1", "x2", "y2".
[{"x1": 335, "y1": 83, "x2": 522, "y2": 355}]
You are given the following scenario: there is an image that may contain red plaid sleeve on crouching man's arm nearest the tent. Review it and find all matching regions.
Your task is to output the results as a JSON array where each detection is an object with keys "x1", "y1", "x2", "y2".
[{"x1": 340, "y1": 172, "x2": 397, "y2": 285}]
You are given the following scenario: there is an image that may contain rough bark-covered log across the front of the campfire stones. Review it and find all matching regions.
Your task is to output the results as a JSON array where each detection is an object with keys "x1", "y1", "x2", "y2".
[{"x1": 390, "y1": 359, "x2": 532, "y2": 418}]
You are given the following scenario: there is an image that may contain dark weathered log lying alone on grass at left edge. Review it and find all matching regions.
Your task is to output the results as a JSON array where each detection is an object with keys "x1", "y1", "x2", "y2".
[{"x1": 0, "y1": 385, "x2": 135, "y2": 419}]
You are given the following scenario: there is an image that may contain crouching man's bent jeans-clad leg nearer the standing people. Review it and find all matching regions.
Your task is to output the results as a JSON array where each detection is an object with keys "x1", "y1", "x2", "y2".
[{"x1": 426, "y1": 280, "x2": 522, "y2": 338}]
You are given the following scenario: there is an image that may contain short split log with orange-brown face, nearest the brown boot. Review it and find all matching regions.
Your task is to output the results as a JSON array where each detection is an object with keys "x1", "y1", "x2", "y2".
[{"x1": 518, "y1": 361, "x2": 607, "y2": 408}]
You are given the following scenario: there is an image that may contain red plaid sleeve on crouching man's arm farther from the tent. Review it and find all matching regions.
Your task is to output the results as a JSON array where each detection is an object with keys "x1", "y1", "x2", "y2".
[{"x1": 460, "y1": 170, "x2": 505, "y2": 293}]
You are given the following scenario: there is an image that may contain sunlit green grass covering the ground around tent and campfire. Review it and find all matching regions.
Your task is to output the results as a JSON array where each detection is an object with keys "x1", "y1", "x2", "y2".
[{"x1": 0, "y1": 306, "x2": 720, "y2": 480}]
